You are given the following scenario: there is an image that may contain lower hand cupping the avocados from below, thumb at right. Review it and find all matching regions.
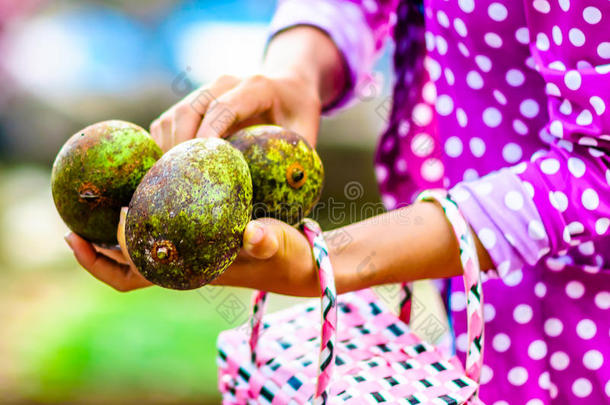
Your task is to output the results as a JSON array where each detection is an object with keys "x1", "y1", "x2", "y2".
[{"x1": 66, "y1": 209, "x2": 320, "y2": 296}]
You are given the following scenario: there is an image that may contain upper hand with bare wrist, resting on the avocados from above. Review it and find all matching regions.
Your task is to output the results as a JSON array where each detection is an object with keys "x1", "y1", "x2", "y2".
[{"x1": 150, "y1": 26, "x2": 348, "y2": 151}]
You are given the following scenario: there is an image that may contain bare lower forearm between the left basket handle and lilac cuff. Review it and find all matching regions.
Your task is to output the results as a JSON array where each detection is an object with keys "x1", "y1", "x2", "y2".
[{"x1": 327, "y1": 202, "x2": 493, "y2": 293}]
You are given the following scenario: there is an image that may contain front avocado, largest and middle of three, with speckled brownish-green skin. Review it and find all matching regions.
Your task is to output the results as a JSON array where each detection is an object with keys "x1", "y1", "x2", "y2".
[{"x1": 125, "y1": 138, "x2": 252, "y2": 290}]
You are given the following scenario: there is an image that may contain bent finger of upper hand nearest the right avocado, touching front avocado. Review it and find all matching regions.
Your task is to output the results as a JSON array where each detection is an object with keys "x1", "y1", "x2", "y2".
[{"x1": 196, "y1": 75, "x2": 273, "y2": 138}]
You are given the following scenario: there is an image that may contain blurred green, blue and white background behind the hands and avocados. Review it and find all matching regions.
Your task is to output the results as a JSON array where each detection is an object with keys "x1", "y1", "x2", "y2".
[{"x1": 0, "y1": 0, "x2": 446, "y2": 404}]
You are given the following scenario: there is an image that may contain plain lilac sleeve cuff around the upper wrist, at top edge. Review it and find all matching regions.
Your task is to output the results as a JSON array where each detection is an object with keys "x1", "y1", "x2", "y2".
[{"x1": 267, "y1": 0, "x2": 375, "y2": 114}]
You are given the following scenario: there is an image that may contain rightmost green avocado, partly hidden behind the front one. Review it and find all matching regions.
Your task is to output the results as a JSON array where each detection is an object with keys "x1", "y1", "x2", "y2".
[{"x1": 227, "y1": 125, "x2": 324, "y2": 225}]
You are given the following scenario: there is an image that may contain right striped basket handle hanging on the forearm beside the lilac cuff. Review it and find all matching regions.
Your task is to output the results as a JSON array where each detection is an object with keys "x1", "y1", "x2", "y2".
[{"x1": 417, "y1": 190, "x2": 484, "y2": 382}]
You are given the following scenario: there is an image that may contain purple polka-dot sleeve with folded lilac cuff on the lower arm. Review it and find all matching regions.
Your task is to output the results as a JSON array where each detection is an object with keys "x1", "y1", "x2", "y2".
[{"x1": 452, "y1": 0, "x2": 610, "y2": 276}]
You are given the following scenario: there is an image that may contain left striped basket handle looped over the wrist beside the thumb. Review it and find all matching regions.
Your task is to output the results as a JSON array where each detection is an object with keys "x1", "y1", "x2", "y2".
[{"x1": 250, "y1": 218, "x2": 337, "y2": 404}]
